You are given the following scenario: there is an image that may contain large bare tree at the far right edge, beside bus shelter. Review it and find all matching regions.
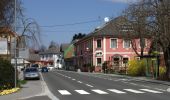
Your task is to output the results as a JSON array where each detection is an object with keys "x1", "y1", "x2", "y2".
[{"x1": 145, "y1": 0, "x2": 170, "y2": 77}]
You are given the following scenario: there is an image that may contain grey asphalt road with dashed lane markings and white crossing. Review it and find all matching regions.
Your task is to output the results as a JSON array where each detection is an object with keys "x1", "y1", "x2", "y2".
[{"x1": 43, "y1": 70, "x2": 170, "y2": 100}]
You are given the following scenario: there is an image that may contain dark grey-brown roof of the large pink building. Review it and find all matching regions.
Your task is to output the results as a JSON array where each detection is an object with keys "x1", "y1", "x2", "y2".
[{"x1": 73, "y1": 16, "x2": 150, "y2": 42}]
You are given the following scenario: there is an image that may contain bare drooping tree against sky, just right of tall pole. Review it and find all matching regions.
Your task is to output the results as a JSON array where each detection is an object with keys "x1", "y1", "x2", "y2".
[{"x1": 18, "y1": 18, "x2": 40, "y2": 49}]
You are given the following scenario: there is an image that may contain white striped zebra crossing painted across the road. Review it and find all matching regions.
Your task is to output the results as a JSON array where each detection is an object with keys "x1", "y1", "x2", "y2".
[{"x1": 58, "y1": 89, "x2": 163, "y2": 95}]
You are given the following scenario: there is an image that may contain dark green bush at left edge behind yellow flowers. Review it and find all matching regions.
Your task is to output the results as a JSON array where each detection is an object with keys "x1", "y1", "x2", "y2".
[{"x1": 0, "y1": 58, "x2": 15, "y2": 90}]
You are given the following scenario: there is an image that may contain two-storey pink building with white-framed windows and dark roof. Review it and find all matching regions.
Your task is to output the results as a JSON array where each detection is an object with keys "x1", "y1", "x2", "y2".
[{"x1": 74, "y1": 18, "x2": 150, "y2": 72}]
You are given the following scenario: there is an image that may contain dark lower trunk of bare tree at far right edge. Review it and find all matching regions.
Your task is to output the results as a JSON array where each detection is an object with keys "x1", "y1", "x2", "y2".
[{"x1": 164, "y1": 47, "x2": 170, "y2": 79}]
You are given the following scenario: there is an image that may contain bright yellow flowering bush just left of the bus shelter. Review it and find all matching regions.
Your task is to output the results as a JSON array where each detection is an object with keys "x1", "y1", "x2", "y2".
[{"x1": 128, "y1": 60, "x2": 145, "y2": 76}]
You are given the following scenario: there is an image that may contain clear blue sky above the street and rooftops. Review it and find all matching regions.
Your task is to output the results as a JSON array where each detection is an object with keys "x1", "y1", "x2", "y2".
[{"x1": 23, "y1": 0, "x2": 134, "y2": 46}]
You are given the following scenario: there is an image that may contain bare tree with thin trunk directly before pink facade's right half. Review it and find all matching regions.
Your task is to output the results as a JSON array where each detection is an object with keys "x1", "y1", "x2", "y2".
[{"x1": 124, "y1": 0, "x2": 150, "y2": 57}]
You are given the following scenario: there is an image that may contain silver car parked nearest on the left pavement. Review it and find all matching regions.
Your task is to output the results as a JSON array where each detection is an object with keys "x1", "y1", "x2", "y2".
[{"x1": 24, "y1": 67, "x2": 40, "y2": 80}]
